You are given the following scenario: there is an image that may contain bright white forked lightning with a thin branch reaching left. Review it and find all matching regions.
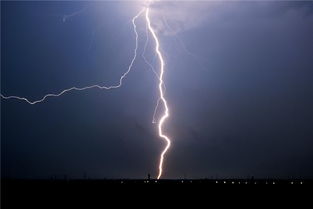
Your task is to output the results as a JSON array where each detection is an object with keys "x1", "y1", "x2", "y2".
[{"x1": 0, "y1": 4, "x2": 171, "y2": 179}]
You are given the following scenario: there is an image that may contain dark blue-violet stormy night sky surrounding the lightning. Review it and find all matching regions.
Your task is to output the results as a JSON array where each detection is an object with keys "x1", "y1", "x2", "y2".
[{"x1": 1, "y1": 2, "x2": 313, "y2": 178}]
